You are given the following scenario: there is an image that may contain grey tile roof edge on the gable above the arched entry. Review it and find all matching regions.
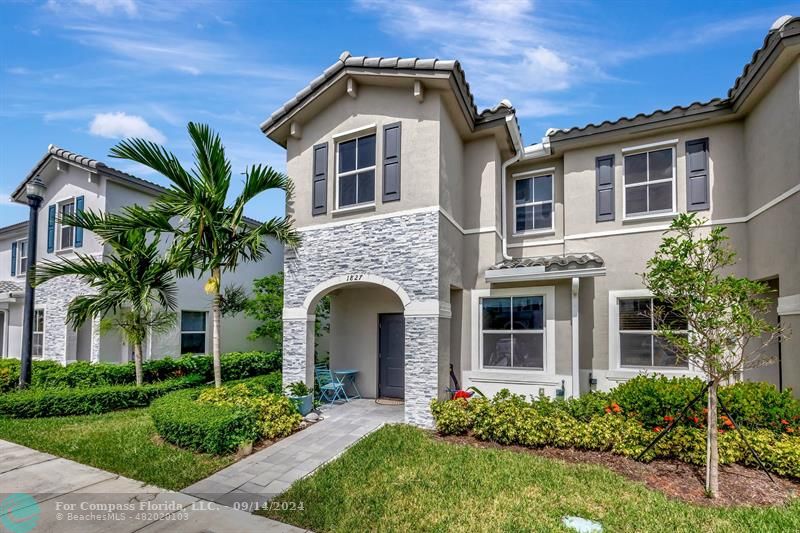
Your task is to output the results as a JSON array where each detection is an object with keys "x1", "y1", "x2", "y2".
[{"x1": 261, "y1": 51, "x2": 519, "y2": 132}]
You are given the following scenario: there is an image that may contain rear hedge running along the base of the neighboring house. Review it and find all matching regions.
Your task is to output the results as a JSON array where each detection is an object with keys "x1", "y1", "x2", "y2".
[{"x1": 0, "y1": 352, "x2": 281, "y2": 392}]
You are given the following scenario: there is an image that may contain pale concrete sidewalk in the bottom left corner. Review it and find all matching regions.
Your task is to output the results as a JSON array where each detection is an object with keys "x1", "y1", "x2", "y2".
[{"x1": 0, "y1": 440, "x2": 303, "y2": 533}]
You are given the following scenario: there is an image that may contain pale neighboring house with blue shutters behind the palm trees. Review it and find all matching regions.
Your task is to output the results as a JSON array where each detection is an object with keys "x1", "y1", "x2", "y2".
[{"x1": 0, "y1": 145, "x2": 283, "y2": 362}]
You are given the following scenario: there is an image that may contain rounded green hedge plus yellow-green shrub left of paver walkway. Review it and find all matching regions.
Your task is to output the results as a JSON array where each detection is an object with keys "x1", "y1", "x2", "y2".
[{"x1": 150, "y1": 373, "x2": 302, "y2": 454}]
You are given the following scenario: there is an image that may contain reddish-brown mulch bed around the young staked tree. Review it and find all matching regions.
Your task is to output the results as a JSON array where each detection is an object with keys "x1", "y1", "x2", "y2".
[{"x1": 434, "y1": 434, "x2": 800, "y2": 506}]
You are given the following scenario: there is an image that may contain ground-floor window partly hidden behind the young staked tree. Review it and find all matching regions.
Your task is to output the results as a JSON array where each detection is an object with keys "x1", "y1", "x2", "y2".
[{"x1": 618, "y1": 298, "x2": 689, "y2": 368}]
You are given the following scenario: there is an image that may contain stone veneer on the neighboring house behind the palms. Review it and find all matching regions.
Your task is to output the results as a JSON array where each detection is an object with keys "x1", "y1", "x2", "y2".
[{"x1": 35, "y1": 277, "x2": 100, "y2": 363}]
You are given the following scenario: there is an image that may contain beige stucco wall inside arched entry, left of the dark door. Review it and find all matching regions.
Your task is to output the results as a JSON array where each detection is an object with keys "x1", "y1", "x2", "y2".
[{"x1": 330, "y1": 287, "x2": 403, "y2": 398}]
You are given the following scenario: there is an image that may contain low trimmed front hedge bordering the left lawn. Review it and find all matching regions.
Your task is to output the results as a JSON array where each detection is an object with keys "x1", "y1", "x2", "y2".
[{"x1": 0, "y1": 376, "x2": 205, "y2": 418}]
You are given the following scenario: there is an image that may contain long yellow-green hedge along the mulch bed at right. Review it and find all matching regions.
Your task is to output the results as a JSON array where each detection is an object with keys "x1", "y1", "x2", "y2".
[{"x1": 431, "y1": 390, "x2": 800, "y2": 479}]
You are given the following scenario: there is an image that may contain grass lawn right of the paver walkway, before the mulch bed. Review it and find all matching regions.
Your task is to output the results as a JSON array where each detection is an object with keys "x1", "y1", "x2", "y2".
[{"x1": 264, "y1": 426, "x2": 800, "y2": 533}]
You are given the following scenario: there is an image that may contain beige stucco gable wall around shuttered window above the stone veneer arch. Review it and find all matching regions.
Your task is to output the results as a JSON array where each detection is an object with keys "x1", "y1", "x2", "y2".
[{"x1": 286, "y1": 85, "x2": 442, "y2": 228}]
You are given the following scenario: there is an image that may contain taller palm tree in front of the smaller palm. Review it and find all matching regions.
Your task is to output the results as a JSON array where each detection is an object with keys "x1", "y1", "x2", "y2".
[{"x1": 110, "y1": 122, "x2": 299, "y2": 387}]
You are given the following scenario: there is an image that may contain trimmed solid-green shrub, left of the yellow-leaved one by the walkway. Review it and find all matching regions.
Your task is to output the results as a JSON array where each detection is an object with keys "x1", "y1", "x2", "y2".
[{"x1": 150, "y1": 389, "x2": 259, "y2": 454}]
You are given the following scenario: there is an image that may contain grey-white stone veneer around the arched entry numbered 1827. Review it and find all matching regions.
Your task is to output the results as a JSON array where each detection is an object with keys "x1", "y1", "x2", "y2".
[{"x1": 283, "y1": 210, "x2": 439, "y2": 426}]
